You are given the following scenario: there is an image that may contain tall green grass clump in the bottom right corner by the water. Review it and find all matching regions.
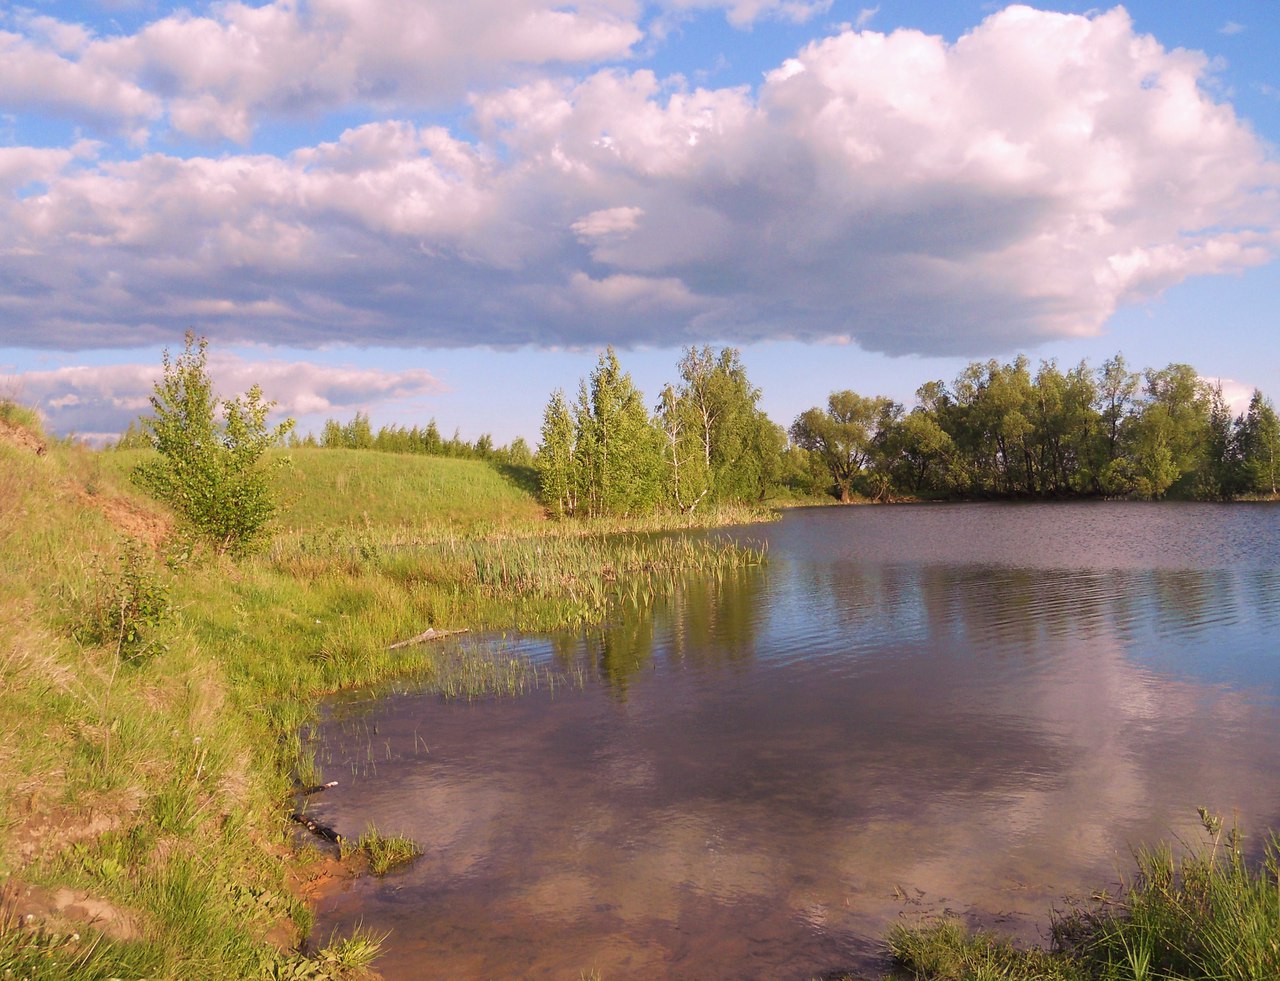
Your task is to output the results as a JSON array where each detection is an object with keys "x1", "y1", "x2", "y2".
[{"x1": 888, "y1": 808, "x2": 1280, "y2": 981}]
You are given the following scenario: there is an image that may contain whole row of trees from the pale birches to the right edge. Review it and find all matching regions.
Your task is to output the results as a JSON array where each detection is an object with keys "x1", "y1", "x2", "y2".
[{"x1": 534, "y1": 347, "x2": 1280, "y2": 516}]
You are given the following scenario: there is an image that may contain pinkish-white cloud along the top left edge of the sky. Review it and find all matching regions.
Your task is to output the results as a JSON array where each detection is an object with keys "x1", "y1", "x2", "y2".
[{"x1": 0, "y1": 0, "x2": 643, "y2": 142}]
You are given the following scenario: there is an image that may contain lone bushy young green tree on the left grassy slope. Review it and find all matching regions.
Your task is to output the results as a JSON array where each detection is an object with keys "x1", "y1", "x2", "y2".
[{"x1": 134, "y1": 332, "x2": 293, "y2": 552}]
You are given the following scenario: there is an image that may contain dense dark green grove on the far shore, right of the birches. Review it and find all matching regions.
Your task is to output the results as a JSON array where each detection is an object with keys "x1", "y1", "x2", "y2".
[{"x1": 791, "y1": 355, "x2": 1280, "y2": 499}]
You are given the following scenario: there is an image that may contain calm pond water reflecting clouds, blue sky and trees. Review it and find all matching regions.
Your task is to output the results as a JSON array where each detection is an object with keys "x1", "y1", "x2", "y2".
[{"x1": 311, "y1": 503, "x2": 1280, "y2": 980}]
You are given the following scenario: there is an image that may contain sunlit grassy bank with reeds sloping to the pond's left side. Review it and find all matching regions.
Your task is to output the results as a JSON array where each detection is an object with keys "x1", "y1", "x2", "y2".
[{"x1": 0, "y1": 416, "x2": 759, "y2": 978}]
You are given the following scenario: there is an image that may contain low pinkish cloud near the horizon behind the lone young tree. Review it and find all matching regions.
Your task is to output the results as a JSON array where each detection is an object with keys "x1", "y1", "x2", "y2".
[{"x1": 0, "y1": 353, "x2": 443, "y2": 438}]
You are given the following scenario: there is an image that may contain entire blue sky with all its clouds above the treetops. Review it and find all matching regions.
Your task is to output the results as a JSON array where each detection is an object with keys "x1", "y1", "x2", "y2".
[{"x1": 0, "y1": 0, "x2": 1280, "y2": 444}]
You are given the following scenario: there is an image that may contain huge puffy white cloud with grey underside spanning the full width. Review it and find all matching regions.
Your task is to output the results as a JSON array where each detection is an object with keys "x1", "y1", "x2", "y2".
[{"x1": 0, "y1": 0, "x2": 1280, "y2": 355}]
